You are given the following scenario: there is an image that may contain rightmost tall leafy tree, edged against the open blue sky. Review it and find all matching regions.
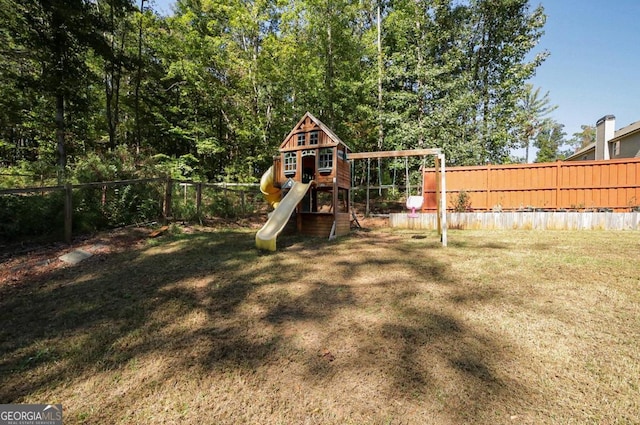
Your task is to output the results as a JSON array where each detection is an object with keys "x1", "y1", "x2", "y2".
[{"x1": 470, "y1": 0, "x2": 547, "y2": 162}]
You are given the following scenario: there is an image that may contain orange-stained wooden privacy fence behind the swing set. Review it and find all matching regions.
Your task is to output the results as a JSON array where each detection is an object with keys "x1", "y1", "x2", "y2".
[{"x1": 422, "y1": 158, "x2": 640, "y2": 211}]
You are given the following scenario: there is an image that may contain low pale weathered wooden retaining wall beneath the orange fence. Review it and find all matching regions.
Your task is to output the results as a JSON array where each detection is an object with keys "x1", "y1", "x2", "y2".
[{"x1": 389, "y1": 211, "x2": 640, "y2": 230}]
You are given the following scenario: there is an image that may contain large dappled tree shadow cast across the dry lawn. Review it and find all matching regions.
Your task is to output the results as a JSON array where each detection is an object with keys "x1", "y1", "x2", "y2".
[{"x1": 0, "y1": 225, "x2": 528, "y2": 419}]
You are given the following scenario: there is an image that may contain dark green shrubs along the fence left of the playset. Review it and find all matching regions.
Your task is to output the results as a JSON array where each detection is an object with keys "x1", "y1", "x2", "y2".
[{"x1": 0, "y1": 178, "x2": 261, "y2": 243}]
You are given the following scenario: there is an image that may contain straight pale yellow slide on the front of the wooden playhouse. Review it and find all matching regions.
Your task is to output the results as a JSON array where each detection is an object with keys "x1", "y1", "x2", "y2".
[{"x1": 256, "y1": 169, "x2": 311, "y2": 251}]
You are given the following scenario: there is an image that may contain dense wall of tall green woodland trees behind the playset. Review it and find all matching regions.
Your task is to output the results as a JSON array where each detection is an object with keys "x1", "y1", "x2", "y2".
[{"x1": 0, "y1": 0, "x2": 546, "y2": 182}]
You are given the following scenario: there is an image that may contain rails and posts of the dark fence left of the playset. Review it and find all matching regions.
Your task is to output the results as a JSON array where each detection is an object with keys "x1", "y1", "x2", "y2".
[{"x1": 0, "y1": 178, "x2": 258, "y2": 242}]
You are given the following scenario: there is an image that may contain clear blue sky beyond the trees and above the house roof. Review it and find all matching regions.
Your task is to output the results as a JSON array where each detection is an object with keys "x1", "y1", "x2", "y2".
[{"x1": 154, "y1": 0, "x2": 640, "y2": 142}]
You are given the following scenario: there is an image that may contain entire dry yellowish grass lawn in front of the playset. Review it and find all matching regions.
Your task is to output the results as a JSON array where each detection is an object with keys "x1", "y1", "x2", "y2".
[{"x1": 0, "y1": 224, "x2": 640, "y2": 424}]
